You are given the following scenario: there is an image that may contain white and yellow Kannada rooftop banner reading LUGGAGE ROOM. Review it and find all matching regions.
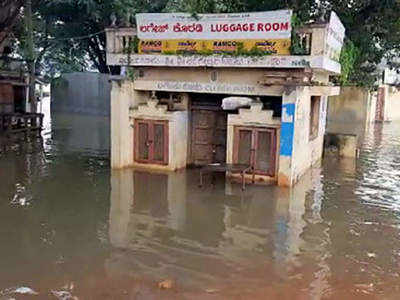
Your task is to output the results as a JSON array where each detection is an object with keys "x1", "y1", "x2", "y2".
[{"x1": 136, "y1": 10, "x2": 292, "y2": 55}]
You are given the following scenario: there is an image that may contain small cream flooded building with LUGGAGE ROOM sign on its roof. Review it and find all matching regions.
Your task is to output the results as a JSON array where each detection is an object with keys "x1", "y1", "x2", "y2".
[{"x1": 106, "y1": 10, "x2": 344, "y2": 186}]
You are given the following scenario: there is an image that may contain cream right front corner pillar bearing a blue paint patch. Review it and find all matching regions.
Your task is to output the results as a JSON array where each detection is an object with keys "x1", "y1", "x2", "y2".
[{"x1": 278, "y1": 89, "x2": 297, "y2": 187}]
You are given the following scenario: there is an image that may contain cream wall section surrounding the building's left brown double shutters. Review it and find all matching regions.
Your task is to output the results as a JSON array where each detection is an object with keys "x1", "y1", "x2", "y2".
[{"x1": 111, "y1": 80, "x2": 189, "y2": 170}]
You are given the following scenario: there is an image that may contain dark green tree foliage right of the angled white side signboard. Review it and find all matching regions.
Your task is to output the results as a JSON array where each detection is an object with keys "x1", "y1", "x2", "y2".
[{"x1": 321, "y1": 0, "x2": 400, "y2": 86}]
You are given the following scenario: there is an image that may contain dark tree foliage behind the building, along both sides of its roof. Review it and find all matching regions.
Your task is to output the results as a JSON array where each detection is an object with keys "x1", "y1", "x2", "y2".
[{"x1": 6, "y1": 0, "x2": 400, "y2": 85}]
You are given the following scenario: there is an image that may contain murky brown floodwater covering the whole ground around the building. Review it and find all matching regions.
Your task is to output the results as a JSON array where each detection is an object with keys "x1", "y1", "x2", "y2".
[{"x1": 0, "y1": 101, "x2": 400, "y2": 300}]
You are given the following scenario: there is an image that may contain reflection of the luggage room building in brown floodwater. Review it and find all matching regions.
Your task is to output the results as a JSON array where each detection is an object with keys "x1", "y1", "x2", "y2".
[{"x1": 107, "y1": 170, "x2": 329, "y2": 296}]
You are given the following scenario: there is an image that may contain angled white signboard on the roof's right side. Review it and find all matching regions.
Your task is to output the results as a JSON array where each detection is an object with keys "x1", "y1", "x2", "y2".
[{"x1": 325, "y1": 11, "x2": 346, "y2": 61}]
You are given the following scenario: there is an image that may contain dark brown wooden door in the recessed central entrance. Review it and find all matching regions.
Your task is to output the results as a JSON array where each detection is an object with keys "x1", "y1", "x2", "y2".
[{"x1": 191, "y1": 109, "x2": 227, "y2": 165}]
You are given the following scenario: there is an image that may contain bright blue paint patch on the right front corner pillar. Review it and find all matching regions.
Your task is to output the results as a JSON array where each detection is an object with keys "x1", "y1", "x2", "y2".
[{"x1": 280, "y1": 103, "x2": 296, "y2": 156}]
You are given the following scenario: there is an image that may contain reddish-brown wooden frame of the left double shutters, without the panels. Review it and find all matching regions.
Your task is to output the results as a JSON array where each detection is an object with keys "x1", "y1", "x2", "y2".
[{"x1": 133, "y1": 119, "x2": 169, "y2": 165}]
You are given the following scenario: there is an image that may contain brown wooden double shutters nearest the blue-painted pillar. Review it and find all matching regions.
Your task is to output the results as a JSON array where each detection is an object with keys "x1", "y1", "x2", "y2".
[{"x1": 233, "y1": 126, "x2": 277, "y2": 176}]
